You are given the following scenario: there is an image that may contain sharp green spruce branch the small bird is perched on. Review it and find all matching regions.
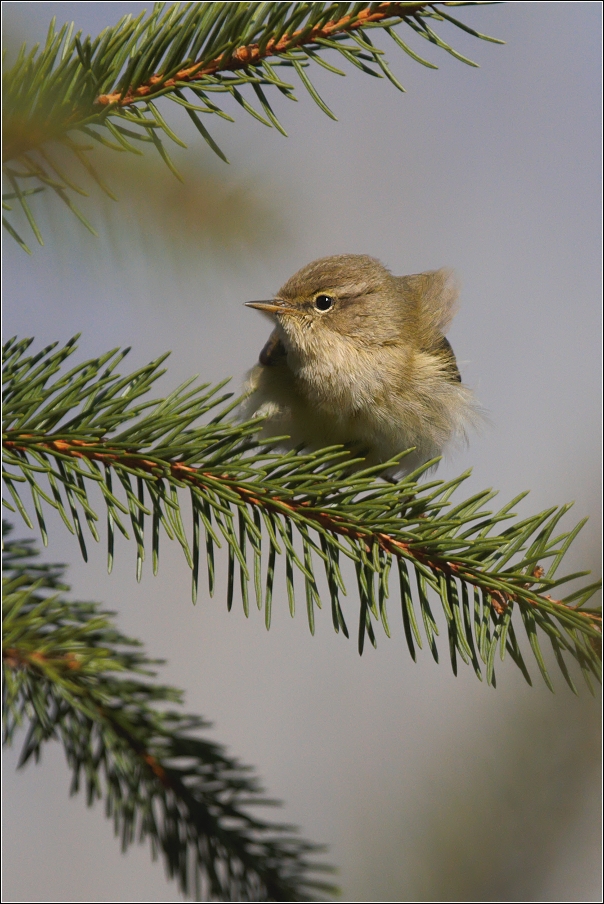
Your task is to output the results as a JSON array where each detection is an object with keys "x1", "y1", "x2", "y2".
[{"x1": 3, "y1": 339, "x2": 601, "y2": 690}]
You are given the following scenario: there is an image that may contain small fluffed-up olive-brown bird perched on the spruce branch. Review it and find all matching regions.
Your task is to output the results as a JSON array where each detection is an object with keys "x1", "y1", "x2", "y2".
[{"x1": 242, "y1": 254, "x2": 480, "y2": 479}]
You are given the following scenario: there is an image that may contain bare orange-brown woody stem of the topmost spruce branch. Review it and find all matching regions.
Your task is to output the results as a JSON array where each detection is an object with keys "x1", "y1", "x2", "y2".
[{"x1": 96, "y1": 3, "x2": 432, "y2": 107}]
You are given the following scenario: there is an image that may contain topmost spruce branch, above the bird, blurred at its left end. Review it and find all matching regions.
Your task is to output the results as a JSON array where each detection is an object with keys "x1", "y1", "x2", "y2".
[{"x1": 3, "y1": 2, "x2": 503, "y2": 251}]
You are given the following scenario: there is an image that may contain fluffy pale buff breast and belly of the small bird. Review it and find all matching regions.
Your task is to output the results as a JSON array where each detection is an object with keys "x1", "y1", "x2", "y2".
[{"x1": 242, "y1": 330, "x2": 480, "y2": 475}]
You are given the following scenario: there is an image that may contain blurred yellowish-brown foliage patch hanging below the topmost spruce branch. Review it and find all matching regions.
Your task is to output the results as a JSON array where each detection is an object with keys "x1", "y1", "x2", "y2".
[{"x1": 3, "y1": 9, "x2": 288, "y2": 267}]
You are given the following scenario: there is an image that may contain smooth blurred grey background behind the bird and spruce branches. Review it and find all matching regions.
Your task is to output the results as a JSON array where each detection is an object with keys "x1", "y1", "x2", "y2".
[{"x1": 3, "y1": 2, "x2": 602, "y2": 902}]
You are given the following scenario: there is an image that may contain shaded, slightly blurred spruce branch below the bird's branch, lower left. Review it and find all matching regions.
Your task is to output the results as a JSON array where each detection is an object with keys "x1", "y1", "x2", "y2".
[{"x1": 2, "y1": 539, "x2": 335, "y2": 901}]
